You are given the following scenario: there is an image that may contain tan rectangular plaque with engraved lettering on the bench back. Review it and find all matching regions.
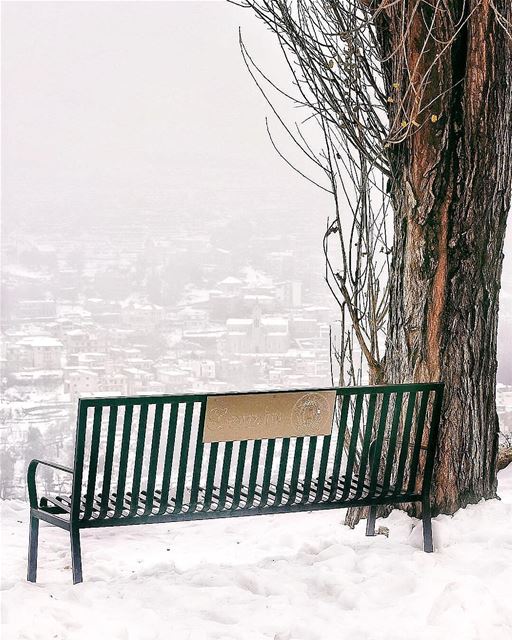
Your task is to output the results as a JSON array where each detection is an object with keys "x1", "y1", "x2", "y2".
[{"x1": 203, "y1": 391, "x2": 336, "y2": 442}]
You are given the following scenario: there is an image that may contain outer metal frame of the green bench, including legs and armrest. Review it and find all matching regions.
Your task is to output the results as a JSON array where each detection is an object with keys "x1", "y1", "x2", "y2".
[{"x1": 27, "y1": 383, "x2": 444, "y2": 584}]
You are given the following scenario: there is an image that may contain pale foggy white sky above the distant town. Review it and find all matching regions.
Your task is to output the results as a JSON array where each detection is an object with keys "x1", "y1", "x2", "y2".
[{"x1": 2, "y1": 1, "x2": 512, "y2": 379}]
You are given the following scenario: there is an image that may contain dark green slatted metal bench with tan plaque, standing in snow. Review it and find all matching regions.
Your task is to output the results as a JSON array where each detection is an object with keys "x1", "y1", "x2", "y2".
[{"x1": 27, "y1": 383, "x2": 443, "y2": 584}]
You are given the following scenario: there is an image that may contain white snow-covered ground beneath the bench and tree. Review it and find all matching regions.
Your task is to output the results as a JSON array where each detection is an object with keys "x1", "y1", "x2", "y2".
[{"x1": 1, "y1": 467, "x2": 512, "y2": 640}]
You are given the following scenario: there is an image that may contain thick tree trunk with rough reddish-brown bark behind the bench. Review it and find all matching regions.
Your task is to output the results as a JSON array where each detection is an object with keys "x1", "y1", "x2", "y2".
[{"x1": 347, "y1": 0, "x2": 512, "y2": 526}]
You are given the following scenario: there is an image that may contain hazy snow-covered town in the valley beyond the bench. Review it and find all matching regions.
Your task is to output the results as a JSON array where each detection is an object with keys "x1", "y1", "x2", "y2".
[{"x1": 0, "y1": 211, "x2": 512, "y2": 498}]
